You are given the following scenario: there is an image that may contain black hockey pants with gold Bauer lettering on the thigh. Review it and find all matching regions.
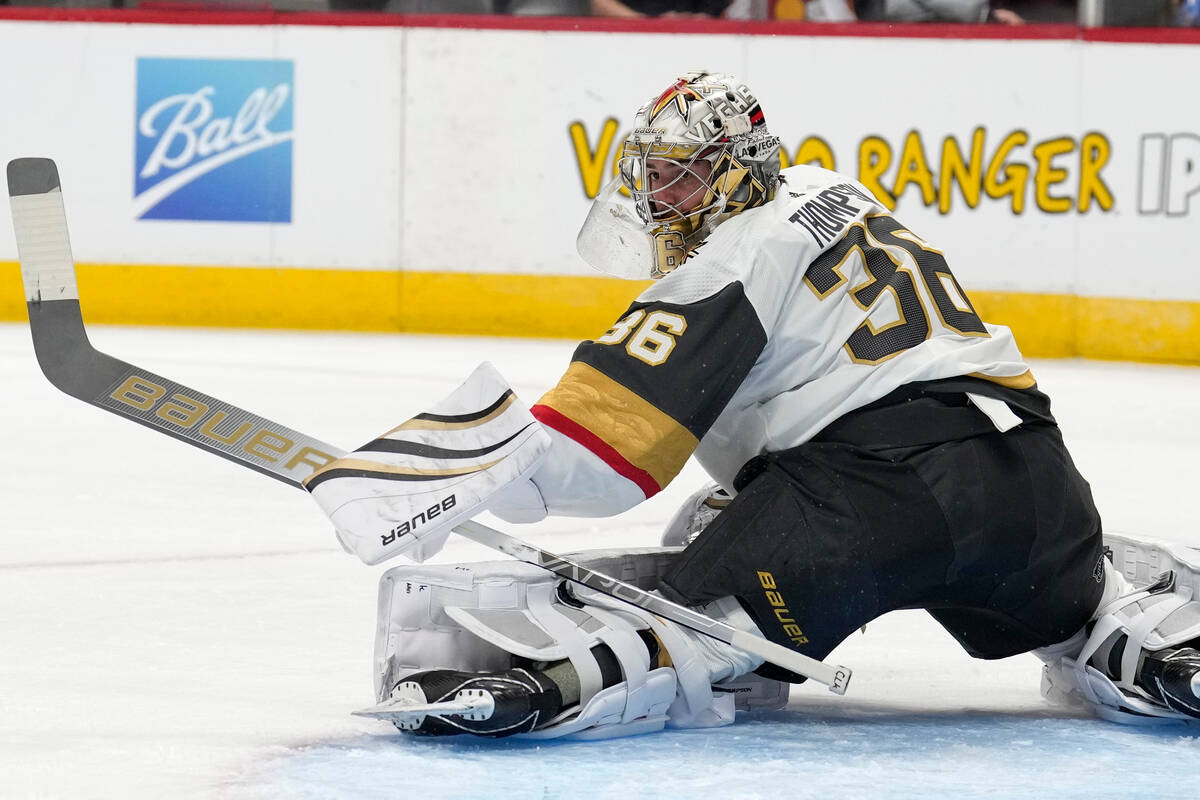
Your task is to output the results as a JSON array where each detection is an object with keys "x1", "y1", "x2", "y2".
[{"x1": 661, "y1": 379, "x2": 1103, "y2": 680}]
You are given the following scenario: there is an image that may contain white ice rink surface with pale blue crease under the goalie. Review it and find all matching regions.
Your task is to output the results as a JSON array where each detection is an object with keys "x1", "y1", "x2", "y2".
[{"x1": 0, "y1": 325, "x2": 1200, "y2": 800}]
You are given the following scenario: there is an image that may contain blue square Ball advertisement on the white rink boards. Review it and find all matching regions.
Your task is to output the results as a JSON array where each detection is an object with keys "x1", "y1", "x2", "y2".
[{"x1": 133, "y1": 58, "x2": 295, "y2": 222}]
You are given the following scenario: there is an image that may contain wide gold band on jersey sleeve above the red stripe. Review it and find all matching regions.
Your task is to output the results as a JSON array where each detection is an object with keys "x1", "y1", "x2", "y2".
[{"x1": 539, "y1": 361, "x2": 700, "y2": 487}]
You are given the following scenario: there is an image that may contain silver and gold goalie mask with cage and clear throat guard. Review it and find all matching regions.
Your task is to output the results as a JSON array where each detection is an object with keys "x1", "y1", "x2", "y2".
[{"x1": 576, "y1": 72, "x2": 779, "y2": 279}]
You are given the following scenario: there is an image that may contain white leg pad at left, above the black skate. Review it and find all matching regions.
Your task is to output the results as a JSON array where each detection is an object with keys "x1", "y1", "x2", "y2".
[{"x1": 376, "y1": 548, "x2": 787, "y2": 739}]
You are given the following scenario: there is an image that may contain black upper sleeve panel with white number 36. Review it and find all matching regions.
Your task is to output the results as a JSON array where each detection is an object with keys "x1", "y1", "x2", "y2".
[{"x1": 575, "y1": 282, "x2": 767, "y2": 439}]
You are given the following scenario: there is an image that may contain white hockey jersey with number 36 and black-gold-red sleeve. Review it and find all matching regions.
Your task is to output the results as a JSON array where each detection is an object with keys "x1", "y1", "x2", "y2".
[{"x1": 516, "y1": 166, "x2": 1034, "y2": 516}]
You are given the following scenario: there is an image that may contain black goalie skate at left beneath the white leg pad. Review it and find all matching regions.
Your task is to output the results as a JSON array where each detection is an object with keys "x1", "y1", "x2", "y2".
[{"x1": 354, "y1": 669, "x2": 563, "y2": 736}]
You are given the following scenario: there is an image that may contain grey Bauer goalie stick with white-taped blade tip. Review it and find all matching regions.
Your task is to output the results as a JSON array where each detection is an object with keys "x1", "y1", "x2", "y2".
[{"x1": 8, "y1": 158, "x2": 851, "y2": 694}]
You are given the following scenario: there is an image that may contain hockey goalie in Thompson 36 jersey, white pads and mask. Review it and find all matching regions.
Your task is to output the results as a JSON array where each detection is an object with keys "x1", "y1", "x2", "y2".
[{"x1": 306, "y1": 72, "x2": 1200, "y2": 738}]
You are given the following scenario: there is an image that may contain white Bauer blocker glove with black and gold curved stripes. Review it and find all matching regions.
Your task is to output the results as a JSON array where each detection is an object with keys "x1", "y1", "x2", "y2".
[{"x1": 305, "y1": 362, "x2": 550, "y2": 564}]
